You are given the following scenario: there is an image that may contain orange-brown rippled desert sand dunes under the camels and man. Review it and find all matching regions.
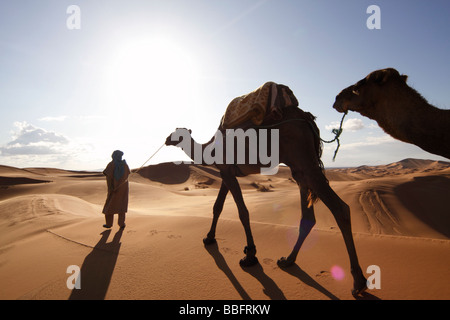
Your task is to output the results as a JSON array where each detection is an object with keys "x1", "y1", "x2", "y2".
[{"x1": 0, "y1": 159, "x2": 450, "y2": 300}]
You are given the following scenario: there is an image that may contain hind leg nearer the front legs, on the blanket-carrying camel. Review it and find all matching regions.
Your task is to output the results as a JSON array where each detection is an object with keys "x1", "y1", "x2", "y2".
[{"x1": 277, "y1": 182, "x2": 316, "y2": 268}]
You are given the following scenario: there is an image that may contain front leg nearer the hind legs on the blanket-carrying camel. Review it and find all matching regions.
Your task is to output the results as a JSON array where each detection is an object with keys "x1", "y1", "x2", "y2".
[{"x1": 221, "y1": 172, "x2": 258, "y2": 267}]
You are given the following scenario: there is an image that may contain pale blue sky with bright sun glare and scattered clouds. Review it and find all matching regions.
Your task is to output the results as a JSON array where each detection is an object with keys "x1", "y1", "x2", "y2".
[{"x1": 0, "y1": 0, "x2": 450, "y2": 170}]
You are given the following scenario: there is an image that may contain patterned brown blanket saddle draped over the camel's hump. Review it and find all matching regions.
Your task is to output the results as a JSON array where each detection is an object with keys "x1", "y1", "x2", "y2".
[{"x1": 221, "y1": 82, "x2": 298, "y2": 129}]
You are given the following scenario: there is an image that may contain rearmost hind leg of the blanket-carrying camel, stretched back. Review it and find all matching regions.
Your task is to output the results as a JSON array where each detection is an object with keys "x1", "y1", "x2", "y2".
[{"x1": 313, "y1": 173, "x2": 367, "y2": 295}]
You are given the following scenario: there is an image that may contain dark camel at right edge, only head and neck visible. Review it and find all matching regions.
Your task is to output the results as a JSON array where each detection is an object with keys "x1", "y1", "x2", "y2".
[{"x1": 333, "y1": 68, "x2": 450, "y2": 159}]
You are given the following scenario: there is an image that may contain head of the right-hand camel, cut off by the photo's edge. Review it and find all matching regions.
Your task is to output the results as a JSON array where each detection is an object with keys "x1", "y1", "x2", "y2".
[{"x1": 333, "y1": 68, "x2": 408, "y2": 114}]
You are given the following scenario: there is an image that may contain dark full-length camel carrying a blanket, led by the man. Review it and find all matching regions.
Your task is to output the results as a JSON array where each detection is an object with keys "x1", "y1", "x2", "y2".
[{"x1": 165, "y1": 87, "x2": 367, "y2": 296}]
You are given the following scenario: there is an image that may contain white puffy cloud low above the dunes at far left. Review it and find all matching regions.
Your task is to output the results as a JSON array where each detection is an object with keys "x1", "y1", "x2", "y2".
[{"x1": 0, "y1": 121, "x2": 69, "y2": 156}]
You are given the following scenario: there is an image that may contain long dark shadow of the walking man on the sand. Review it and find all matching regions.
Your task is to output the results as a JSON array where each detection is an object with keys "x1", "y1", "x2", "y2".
[{"x1": 69, "y1": 229, "x2": 123, "y2": 300}]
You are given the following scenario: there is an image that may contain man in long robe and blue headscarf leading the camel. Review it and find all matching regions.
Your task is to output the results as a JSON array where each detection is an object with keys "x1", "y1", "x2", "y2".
[{"x1": 102, "y1": 150, "x2": 130, "y2": 228}]
